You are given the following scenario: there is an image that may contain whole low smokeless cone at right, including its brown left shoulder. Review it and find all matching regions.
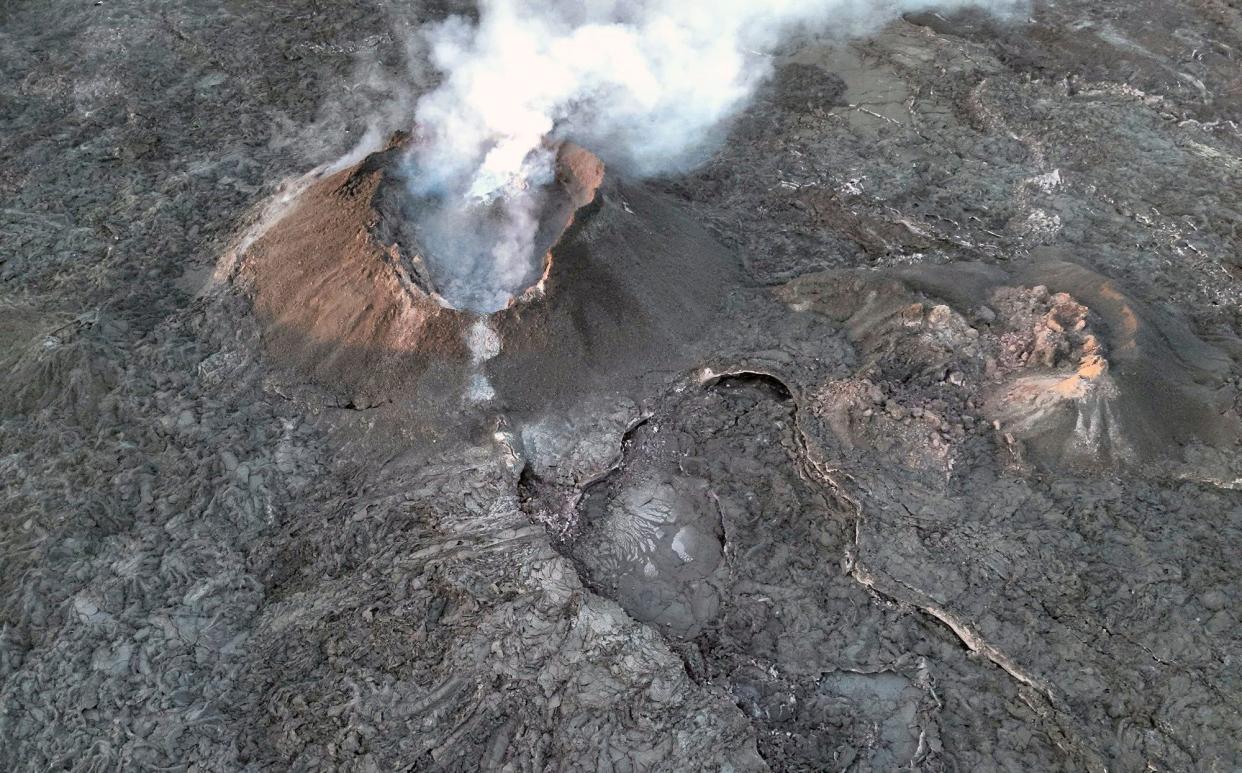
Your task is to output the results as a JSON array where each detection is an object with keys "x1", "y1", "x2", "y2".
[{"x1": 779, "y1": 260, "x2": 1242, "y2": 475}]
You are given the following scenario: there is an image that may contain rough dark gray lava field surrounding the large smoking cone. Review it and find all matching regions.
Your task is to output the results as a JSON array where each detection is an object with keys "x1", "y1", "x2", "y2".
[{"x1": 0, "y1": 0, "x2": 1242, "y2": 772}]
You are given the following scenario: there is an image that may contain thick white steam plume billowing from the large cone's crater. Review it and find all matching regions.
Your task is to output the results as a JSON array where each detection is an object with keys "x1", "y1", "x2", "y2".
[{"x1": 410, "y1": 0, "x2": 1025, "y2": 311}]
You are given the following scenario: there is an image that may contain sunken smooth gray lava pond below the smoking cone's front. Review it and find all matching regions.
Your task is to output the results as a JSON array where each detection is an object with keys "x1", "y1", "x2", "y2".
[{"x1": 569, "y1": 380, "x2": 804, "y2": 639}]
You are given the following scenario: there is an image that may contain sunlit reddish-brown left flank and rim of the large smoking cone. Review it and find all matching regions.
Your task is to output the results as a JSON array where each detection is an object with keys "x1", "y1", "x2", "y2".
[{"x1": 236, "y1": 134, "x2": 604, "y2": 405}]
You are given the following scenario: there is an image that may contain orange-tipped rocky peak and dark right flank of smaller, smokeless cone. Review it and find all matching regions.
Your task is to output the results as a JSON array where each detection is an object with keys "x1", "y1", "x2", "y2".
[{"x1": 984, "y1": 260, "x2": 1242, "y2": 467}]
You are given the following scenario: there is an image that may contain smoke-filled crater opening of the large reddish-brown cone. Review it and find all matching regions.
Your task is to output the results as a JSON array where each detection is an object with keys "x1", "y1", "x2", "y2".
[{"x1": 374, "y1": 142, "x2": 604, "y2": 314}]
